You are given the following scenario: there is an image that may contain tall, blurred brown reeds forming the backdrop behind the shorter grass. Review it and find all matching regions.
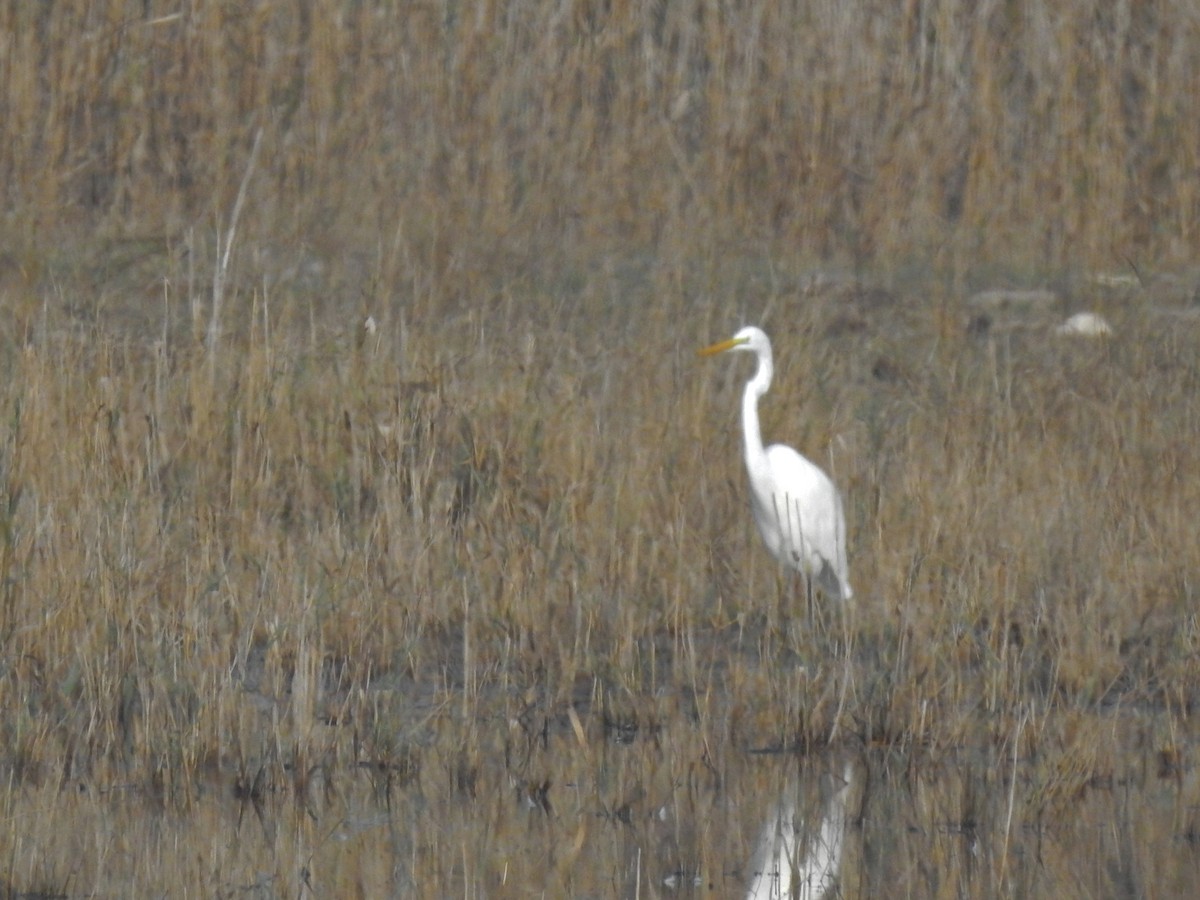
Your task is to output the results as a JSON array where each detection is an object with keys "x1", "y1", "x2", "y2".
[{"x1": 0, "y1": 0, "x2": 1200, "y2": 328}]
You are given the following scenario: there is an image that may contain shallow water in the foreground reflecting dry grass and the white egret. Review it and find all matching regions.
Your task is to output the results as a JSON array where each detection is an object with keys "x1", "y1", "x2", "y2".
[{"x1": 4, "y1": 691, "x2": 1200, "y2": 898}]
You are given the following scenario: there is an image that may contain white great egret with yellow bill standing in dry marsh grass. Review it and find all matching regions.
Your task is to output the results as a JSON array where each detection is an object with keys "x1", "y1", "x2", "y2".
[{"x1": 700, "y1": 325, "x2": 853, "y2": 600}]
